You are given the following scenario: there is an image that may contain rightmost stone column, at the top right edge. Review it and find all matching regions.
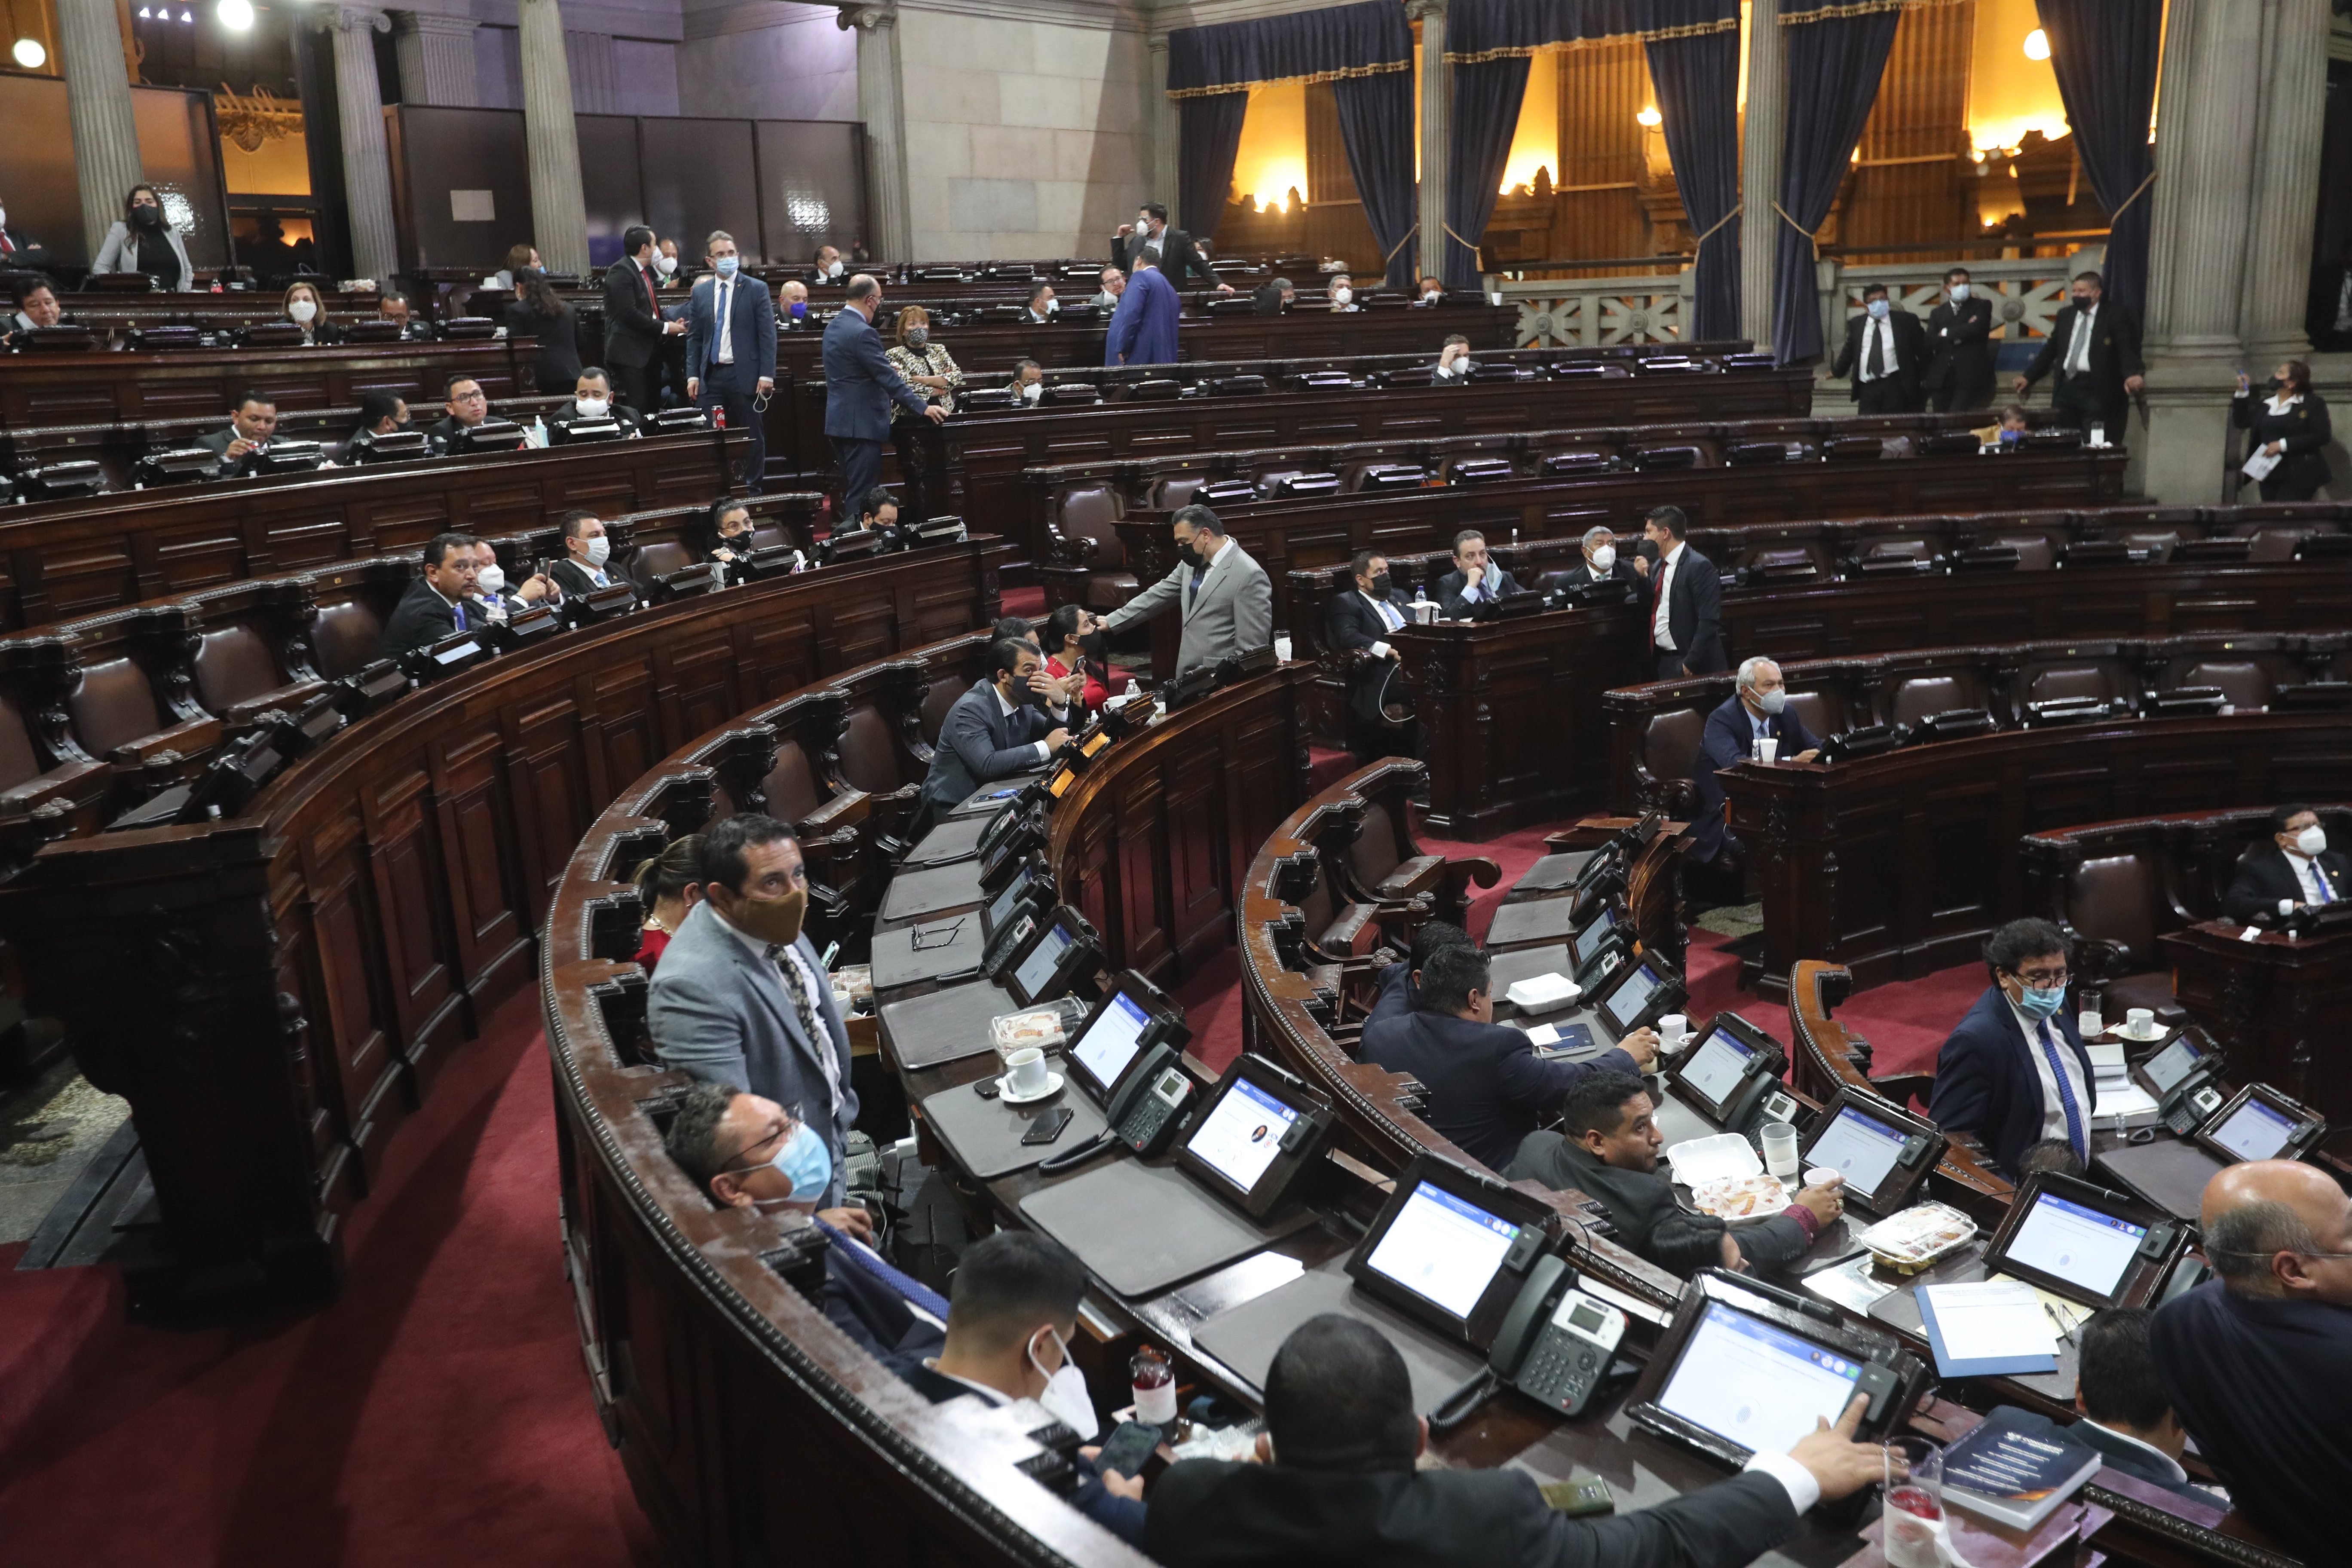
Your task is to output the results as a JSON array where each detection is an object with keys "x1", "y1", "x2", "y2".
[{"x1": 2239, "y1": 0, "x2": 2328, "y2": 369}]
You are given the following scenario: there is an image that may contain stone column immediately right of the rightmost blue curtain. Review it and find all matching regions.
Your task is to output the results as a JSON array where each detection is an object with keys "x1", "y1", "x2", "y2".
[{"x1": 2131, "y1": 0, "x2": 2267, "y2": 505}]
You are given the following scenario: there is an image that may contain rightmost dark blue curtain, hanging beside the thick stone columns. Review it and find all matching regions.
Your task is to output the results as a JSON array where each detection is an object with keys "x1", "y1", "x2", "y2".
[{"x1": 2037, "y1": 0, "x2": 2164, "y2": 320}]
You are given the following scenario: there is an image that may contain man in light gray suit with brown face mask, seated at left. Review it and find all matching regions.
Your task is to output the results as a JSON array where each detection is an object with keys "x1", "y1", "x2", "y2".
[{"x1": 647, "y1": 813, "x2": 858, "y2": 1211}]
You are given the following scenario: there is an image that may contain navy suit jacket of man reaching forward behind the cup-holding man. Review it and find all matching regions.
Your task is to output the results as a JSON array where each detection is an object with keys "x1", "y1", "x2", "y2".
[{"x1": 1357, "y1": 1011, "x2": 1639, "y2": 1171}]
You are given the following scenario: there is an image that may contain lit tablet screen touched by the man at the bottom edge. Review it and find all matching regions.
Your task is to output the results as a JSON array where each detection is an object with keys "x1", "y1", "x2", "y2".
[{"x1": 1658, "y1": 1302, "x2": 1863, "y2": 1453}]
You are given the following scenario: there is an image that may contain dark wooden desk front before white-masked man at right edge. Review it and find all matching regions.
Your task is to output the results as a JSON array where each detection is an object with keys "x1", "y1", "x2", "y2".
[{"x1": 2159, "y1": 921, "x2": 2352, "y2": 1126}]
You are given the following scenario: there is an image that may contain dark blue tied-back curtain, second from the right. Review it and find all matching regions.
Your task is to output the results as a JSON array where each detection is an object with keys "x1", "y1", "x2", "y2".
[{"x1": 1757, "y1": 0, "x2": 1900, "y2": 364}]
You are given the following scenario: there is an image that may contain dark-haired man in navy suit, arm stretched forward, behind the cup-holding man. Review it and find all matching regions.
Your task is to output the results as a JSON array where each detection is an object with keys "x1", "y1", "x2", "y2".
[{"x1": 1360, "y1": 947, "x2": 1658, "y2": 1171}]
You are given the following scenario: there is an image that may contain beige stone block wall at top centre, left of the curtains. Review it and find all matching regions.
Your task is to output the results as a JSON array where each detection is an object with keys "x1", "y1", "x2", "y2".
[{"x1": 898, "y1": 5, "x2": 1152, "y2": 261}]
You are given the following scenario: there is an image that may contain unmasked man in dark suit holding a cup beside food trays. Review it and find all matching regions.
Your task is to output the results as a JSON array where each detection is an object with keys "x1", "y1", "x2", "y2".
[{"x1": 1503, "y1": 1072, "x2": 1847, "y2": 1279}]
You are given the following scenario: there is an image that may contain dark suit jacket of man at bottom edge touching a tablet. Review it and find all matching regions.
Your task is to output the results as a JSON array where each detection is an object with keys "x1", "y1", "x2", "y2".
[{"x1": 1143, "y1": 1460, "x2": 1797, "y2": 1568}]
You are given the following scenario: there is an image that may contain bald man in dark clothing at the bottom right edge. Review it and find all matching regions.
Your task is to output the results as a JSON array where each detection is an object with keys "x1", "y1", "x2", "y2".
[{"x1": 2147, "y1": 1159, "x2": 2352, "y2": 1563}]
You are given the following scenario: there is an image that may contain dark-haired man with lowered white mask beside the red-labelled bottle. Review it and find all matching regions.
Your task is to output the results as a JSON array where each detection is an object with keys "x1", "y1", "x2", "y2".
[{"x1": 889, "y1": 1229, "x2": 1143, "y2": 1547}]
